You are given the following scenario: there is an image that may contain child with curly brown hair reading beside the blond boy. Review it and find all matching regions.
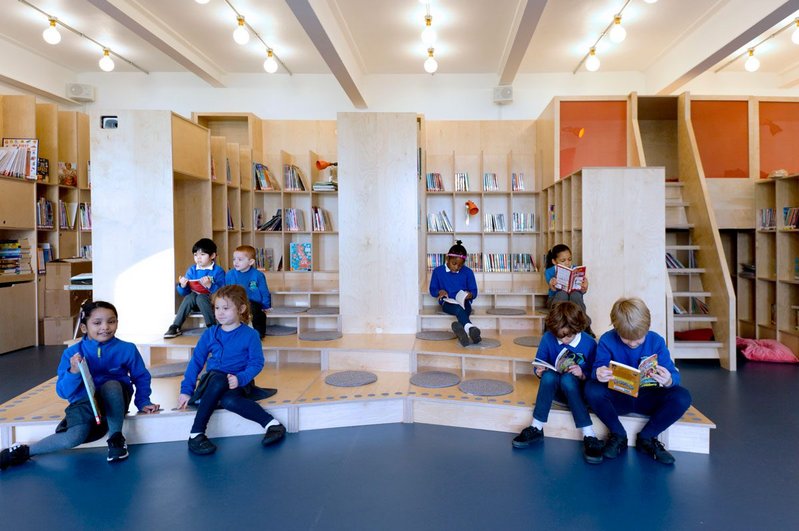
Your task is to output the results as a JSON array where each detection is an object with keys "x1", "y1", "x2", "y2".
[{"x1": 513, "y1": 302, "x2": 602, "y2": 464}]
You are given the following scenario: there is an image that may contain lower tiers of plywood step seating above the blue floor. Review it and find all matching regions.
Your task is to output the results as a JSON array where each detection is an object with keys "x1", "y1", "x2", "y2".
[{"x1": 0, "y1": 334, "x2": 715, "y2": 453}]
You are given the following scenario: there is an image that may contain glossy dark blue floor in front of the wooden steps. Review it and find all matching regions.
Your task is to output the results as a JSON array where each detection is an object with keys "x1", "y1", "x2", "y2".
[{"x1": 0, "y1": 349, "x2": 799, "y2": 530}]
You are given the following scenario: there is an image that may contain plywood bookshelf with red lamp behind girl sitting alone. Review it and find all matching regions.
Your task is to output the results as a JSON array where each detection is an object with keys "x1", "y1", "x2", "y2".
[{"x1": 418, "y1": 121, "x2": 546, "y2": 332}]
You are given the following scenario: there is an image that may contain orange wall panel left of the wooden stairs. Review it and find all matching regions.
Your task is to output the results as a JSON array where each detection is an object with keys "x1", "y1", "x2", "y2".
[{"x1": 560, "y1": 101, "x2": 627, "y2": 177}]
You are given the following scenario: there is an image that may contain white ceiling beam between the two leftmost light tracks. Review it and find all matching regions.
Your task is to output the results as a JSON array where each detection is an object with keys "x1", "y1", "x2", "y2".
[{"x1": 88, "y1": 0, "x2": 225, "y2": 88}]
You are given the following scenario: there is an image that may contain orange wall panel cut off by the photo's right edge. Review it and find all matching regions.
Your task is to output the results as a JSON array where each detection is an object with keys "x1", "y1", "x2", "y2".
[{"x1": 759, "y1": 101, "x2": 799, "y2": 178}]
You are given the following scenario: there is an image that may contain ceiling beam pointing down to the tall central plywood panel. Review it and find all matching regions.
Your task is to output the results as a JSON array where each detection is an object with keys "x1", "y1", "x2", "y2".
[{"x1": 286, "y1": 0, "x2": 367, "y2": 109}]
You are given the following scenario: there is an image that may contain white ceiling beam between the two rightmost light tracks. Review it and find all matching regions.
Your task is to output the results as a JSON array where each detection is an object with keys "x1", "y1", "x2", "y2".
[{"x1": 647, "y1": 0, "x2": 799, "y2": 95}]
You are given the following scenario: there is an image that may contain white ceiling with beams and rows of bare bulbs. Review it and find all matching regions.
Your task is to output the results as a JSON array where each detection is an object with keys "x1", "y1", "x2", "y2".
[{"x1": 0, "y1": 0, "x2": 799, "y2": 106}]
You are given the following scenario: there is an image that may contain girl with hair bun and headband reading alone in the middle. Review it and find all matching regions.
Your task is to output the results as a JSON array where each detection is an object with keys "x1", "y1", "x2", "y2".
[{"x1": 430, "y1": 240, "x2": 482, "y2": 347}]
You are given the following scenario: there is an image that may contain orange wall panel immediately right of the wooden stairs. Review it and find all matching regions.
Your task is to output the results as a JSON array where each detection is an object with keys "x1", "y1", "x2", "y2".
[{"x1": 691, "y1": 100, "x2": 749, "y2": 178}]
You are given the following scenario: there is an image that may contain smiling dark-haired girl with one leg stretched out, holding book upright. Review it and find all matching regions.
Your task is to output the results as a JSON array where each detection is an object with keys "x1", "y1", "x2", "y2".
[{"x1": 0, "y1": 301, "x2": 159, "y2": 470}]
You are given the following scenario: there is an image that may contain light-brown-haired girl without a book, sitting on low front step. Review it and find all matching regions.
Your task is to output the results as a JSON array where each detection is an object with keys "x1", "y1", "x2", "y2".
[{"x1": 178, "y1": 285, "x2": 286, "y2": 455}]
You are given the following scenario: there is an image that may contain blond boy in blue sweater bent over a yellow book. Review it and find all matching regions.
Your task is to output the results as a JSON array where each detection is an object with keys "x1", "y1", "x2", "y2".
[{"x1": 585, "y1": 298, "x2": 691, "y2": 465}]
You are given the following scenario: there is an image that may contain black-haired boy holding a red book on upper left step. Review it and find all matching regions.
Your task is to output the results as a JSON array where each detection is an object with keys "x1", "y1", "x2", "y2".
[{"x1": 164, "y1": 238, "x2": 225, "y2": 339}]
